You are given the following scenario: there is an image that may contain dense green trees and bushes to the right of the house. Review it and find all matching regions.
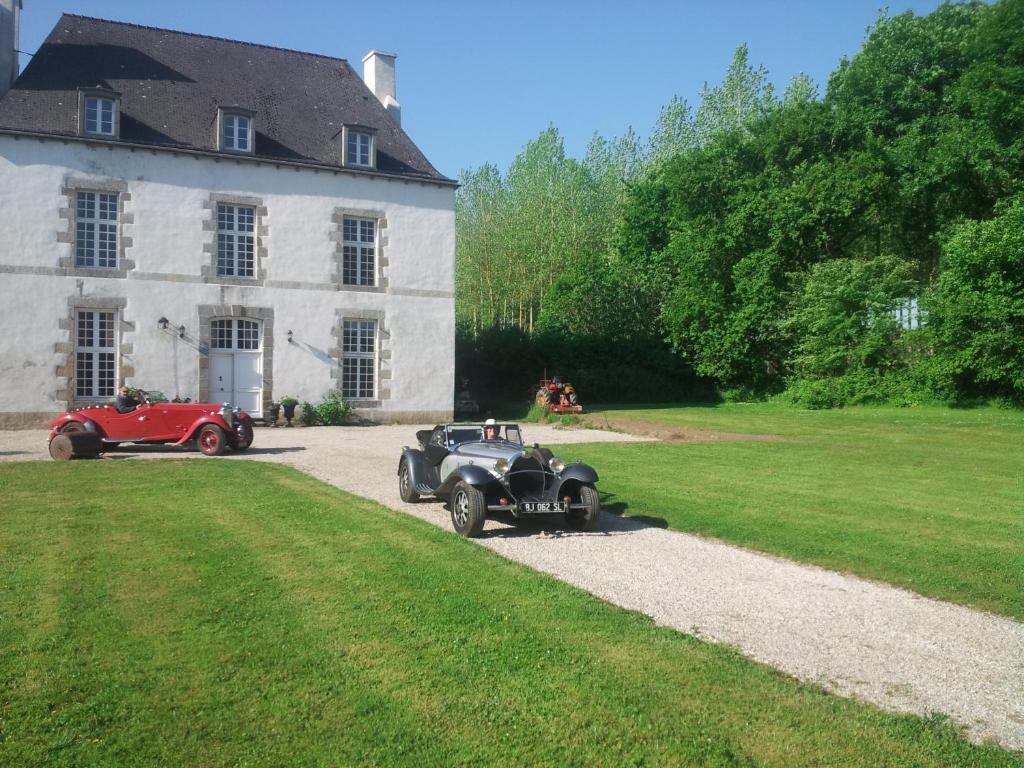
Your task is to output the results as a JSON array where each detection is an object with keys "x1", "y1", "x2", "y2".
[{"x1": 457, "y1": 0, "x2": 1024, "y2": 406}]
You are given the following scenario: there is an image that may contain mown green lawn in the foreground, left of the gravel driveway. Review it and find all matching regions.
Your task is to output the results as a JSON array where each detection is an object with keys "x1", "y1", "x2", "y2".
[{"x1": 0, "y1": 460, "x2": 1021, "y2": 768}]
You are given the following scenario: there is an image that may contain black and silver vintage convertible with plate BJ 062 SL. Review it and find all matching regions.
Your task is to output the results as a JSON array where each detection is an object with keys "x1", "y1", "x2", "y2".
[{"x1": 398, "y1": 422, "x2": 601, "y2": 537}]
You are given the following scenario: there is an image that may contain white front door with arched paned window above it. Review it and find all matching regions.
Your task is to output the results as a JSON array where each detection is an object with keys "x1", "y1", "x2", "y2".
[{"x1": 210, "y1": 319, "x2": 263, "y2": 417}]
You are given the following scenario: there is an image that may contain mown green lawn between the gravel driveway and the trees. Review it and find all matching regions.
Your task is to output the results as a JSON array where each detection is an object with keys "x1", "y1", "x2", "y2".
[{"x1": 561, "y1": 403, "x2": 1024, "y2": 618}]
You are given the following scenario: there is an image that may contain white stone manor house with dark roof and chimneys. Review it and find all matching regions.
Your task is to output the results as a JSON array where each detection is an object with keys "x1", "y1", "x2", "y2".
[{"x1": 0, "y1": 0, "x2": 456, "y2": 426}]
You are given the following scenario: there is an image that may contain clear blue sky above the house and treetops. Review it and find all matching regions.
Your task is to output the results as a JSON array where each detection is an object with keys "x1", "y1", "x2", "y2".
[{"x1": 20, "y1": 0, "x2": 939, "y2": 177}]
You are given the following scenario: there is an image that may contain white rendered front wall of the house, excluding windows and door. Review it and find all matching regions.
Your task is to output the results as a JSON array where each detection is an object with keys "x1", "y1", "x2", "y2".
[{"x1": 0, "y1": 136, "x2": 455, "y2": 428}]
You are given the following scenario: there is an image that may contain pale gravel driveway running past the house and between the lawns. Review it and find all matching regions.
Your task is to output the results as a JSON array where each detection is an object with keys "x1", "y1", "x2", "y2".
[{"x1": 0, "y1": 425, "x2": 1024, "y2": 750}]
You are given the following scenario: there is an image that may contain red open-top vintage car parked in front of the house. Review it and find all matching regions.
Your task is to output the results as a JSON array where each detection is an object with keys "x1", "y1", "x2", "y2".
[{"x1": 50, "y1": 389, "x2": 253, "y2": 456}]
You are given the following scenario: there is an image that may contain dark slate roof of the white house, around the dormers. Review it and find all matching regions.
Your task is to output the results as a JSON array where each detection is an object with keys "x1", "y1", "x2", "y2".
[{"x1": 0, "y1": 14, "x2": 447, "y2": 181}]
